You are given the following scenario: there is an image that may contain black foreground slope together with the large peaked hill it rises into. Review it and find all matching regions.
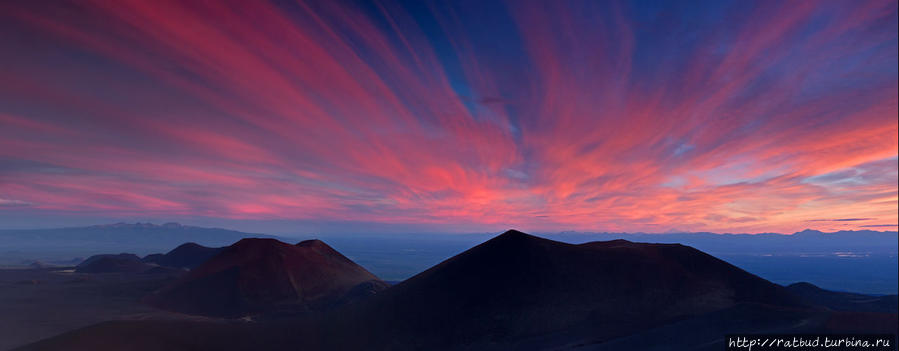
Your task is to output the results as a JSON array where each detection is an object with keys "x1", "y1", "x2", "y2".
[{"x1": 14, "y1": 231, "x2": 897, "y2": 350}]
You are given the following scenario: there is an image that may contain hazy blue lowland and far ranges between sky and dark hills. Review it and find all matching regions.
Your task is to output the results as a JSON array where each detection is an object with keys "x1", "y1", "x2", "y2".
[{"x1": 0, "y1": 223, "x2": 899, "y2": 294}]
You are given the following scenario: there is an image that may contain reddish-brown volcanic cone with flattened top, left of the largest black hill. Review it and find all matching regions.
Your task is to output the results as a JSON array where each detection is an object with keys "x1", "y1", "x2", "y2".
[{"x1": 145, "y1": 239, "x2": 386, "y2": 317}]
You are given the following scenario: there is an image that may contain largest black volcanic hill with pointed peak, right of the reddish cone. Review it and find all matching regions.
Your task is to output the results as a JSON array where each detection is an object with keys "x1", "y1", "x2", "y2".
[{"x1": 322, "y1": 230, "x2": 802, "y2": 349}]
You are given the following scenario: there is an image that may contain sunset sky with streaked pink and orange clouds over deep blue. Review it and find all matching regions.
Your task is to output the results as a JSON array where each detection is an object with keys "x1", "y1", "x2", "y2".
[{"x1": 0, "y1": 0, "x2": 899, "y2": 233}]
